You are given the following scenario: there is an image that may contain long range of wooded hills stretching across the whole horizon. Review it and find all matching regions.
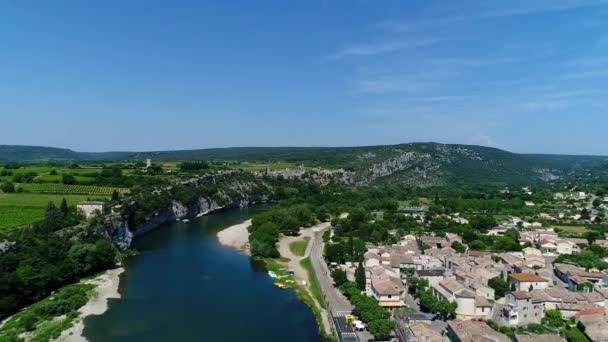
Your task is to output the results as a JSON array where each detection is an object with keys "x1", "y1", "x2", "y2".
[{"x1": 0, "y1": 143, "x2": 608, "y2": 187}]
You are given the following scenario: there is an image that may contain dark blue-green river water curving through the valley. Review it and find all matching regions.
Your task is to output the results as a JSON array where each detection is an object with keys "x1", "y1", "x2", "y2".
[{"x1": 84, "y1": 208, "x2": 320, "y2": 341}]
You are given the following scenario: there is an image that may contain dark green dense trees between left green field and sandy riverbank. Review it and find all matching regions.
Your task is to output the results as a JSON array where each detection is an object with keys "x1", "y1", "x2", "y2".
[{"x1": 0, "y1": 203, "x2": 119, "y2": 318}]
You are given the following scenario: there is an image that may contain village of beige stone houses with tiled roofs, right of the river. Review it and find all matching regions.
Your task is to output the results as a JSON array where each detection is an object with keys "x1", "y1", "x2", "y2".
[{"x1": 331, "y1": 193, "x2": 608, "y2": 342}]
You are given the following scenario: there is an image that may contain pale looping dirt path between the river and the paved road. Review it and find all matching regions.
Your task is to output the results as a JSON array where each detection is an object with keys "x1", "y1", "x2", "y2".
[{"x1": 278, "y1": 222, "x2": 332, "y2": 335}]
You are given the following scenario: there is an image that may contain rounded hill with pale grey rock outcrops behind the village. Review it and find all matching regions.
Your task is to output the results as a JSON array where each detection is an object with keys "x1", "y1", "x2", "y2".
[{"x1": 352, "y1": 143, "x2": 564, "y2": 187}]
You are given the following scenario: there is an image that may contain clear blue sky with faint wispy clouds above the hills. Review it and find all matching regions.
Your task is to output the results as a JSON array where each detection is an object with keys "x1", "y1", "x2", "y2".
[{"x1": 0, "y1": 0, "x2": 608, "y2": 155}]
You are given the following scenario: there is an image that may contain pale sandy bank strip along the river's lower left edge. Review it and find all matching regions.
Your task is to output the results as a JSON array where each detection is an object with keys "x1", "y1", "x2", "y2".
[{"x1": 57, "y1": 267, "x2": 124, "y2": 342}]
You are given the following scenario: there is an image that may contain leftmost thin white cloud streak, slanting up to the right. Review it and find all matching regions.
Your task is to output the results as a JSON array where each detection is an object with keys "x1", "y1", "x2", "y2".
[{"x1": 327, "y1": 39, "x2": 437, "y2": 60}]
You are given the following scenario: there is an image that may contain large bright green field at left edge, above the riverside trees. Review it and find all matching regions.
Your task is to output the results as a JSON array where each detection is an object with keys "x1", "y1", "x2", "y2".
[{"x1": 0, "y1": 193, "x2": 107, "y2": 229}]
